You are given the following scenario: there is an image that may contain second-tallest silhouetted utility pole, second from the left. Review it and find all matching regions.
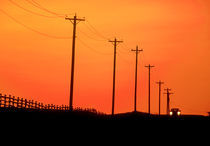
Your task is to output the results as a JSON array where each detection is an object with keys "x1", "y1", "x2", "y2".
[{"x1": 109, "y1": 38, "x2": 123, "y2": 115}]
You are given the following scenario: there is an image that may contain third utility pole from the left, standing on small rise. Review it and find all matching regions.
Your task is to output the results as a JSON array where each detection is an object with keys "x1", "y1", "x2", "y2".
[{"x1": 131, "y1": 46, "x2": 143, "y2": 112}]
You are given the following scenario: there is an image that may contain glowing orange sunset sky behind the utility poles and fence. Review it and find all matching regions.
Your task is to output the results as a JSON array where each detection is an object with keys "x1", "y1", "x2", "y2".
[{"x1": 0, "y1": 0, "x2": 210, "y2": 115}]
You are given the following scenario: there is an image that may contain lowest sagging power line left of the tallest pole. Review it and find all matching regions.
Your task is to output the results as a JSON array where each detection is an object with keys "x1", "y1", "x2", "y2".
[{"x1": 0, "y1": 9, "x2": 72, "y2": 39}]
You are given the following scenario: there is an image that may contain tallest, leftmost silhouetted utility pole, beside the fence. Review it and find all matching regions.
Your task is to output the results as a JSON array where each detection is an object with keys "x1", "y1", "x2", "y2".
[{"x1": 65, "y1": 14, "x2": 85, "y2": 110}]
